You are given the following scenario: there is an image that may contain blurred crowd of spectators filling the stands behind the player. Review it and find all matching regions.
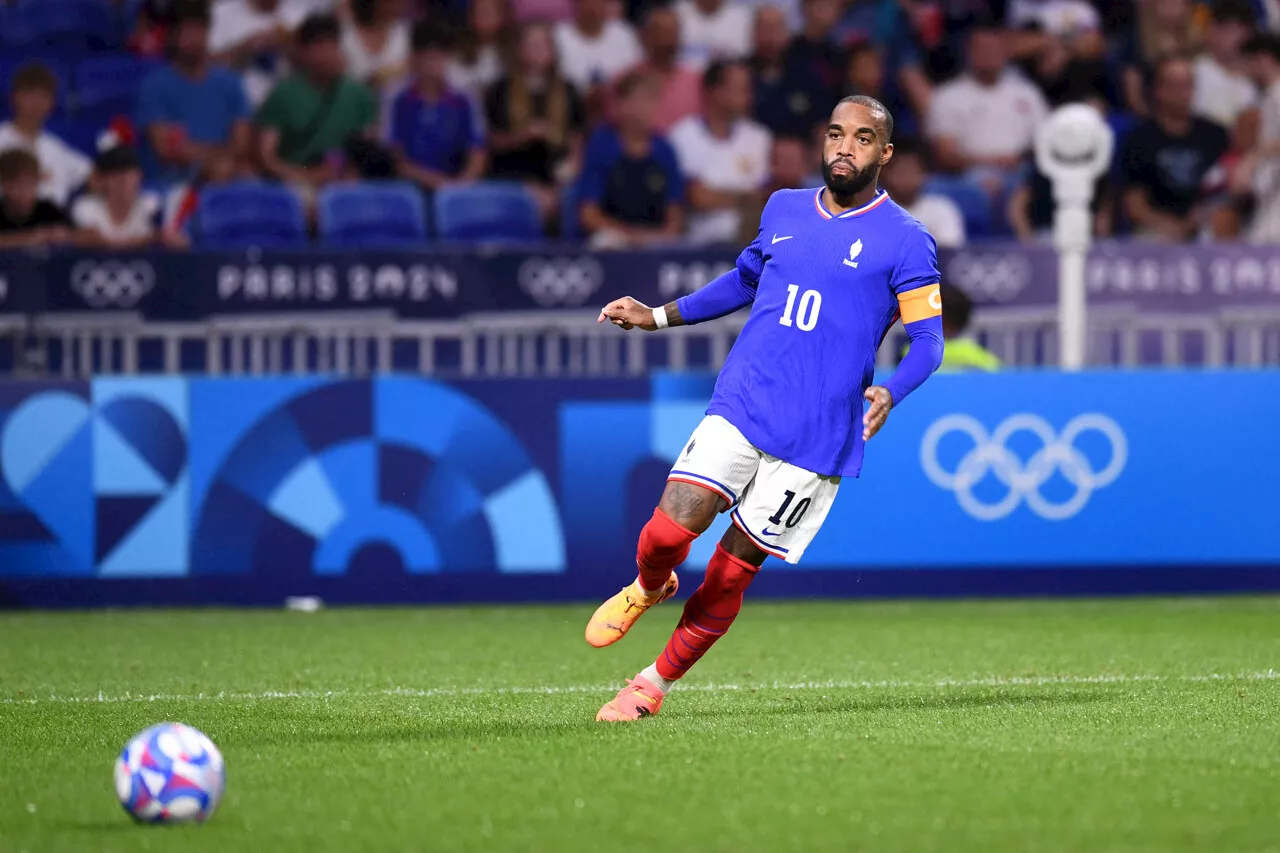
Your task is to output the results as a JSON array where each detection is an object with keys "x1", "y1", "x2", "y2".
[{"x1": 0, "y1": 0, "x2": 1280, "y2": 247}]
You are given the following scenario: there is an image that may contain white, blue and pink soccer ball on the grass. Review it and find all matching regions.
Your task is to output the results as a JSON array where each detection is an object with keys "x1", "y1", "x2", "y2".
[{"x1": 115, "y1": 722, "x2": 227, "y2": 824}]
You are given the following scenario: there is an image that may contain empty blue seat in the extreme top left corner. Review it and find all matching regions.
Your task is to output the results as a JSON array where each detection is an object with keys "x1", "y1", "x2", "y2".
[{"x1": 0, "y1": 0, "x2": 122, "y2": 56}]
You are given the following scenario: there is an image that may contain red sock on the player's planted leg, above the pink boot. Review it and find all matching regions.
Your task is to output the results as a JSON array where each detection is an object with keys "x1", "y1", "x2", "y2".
[{"x1": 657, "y1": 544, "x2": 759, "y2": 681}]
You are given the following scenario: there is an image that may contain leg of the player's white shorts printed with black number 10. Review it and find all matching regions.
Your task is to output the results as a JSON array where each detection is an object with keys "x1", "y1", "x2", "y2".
[{"x1": 733, "y1": 456, "x2": 840, "y2": 564}]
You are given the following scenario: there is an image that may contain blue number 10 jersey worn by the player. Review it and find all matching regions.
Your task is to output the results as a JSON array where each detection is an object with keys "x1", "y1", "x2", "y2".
[{"x1": 680, "y1": 190, "x2": 942, "y2": 476}]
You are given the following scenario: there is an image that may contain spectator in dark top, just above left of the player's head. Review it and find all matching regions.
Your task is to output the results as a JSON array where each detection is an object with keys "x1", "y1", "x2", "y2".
[{"x1": 750, "y1": 6, "x2": 836, "y2": 137}]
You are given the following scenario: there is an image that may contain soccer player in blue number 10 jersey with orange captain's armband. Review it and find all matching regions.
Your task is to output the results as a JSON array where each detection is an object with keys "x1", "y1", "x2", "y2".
[{"x1": 586, "y1": 96, "x2": 942, "y2": 721}]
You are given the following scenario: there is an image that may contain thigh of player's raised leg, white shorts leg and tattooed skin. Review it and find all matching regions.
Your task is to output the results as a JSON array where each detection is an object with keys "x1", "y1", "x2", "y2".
[{"x1": 658, "y1": 415, "x2": 762, "y2": 533}]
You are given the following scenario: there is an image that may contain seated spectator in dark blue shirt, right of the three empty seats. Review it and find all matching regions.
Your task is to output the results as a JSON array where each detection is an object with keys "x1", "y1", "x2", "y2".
[{"x1": 581, "y1": 73, "x2": 685, "y2": 248}]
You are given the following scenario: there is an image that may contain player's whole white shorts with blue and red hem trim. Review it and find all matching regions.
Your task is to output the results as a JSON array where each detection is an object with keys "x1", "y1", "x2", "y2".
[{"x1": 667, "y1": 415, "x2": 840, "y2": 564}]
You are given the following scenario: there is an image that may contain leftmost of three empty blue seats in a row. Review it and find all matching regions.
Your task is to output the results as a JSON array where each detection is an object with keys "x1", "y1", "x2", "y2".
[{"x1": 195, "y1": 181, "x2": 307, "y2": 248}]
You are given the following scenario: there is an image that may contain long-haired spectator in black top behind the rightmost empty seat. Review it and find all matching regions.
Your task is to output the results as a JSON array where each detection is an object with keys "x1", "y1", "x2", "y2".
[{"x1": 485, "y1": 23, "x2": 584, "y2": 216}]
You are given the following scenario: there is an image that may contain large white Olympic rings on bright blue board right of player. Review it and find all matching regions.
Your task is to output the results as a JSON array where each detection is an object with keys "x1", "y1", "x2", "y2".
[{"x1": 920, "y1": 412, "x2": 1129, "y2": 521}]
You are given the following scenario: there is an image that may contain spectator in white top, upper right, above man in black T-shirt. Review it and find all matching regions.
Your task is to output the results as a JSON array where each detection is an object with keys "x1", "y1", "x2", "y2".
[{"x1": 1192, "y1": 0, "x2": 1258, "y2": 129}]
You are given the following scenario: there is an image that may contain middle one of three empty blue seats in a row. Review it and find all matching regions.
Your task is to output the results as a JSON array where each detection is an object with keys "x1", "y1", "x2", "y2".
[{"x1": 316, "y1": 181, "x2": 426, "y2": 246}]
